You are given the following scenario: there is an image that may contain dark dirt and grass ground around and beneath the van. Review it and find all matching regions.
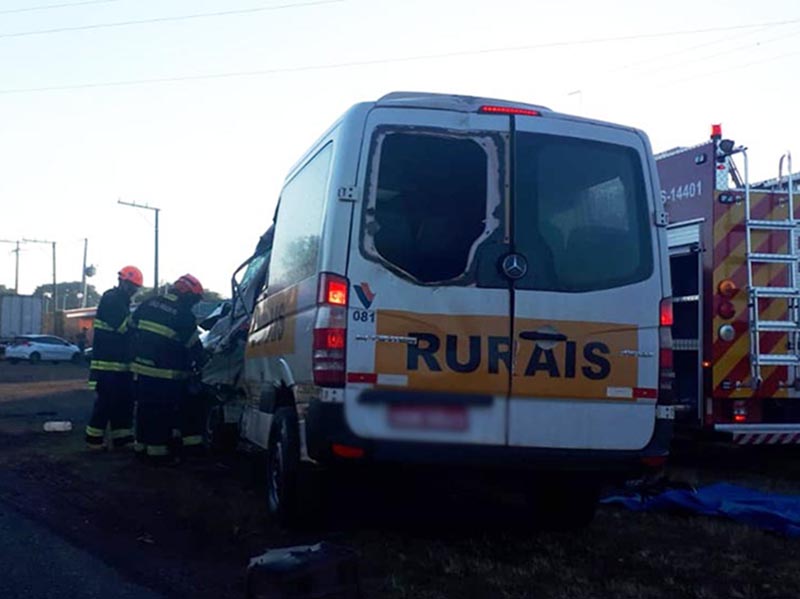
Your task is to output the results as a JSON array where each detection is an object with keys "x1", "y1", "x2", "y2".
[{"x1": 0, "y1": 362, "x2": 800, "y2": 599}]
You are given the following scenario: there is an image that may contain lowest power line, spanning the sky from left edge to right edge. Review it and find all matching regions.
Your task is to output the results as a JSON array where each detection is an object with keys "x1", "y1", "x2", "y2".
[{"x1": 0, "y1": 16, "x2": 800, "y2": 94}]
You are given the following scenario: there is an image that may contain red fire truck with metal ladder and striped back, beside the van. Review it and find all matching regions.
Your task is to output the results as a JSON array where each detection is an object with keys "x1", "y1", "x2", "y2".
[{"x1": 656, "y1": 125, "x2": 800, "y2": 445}]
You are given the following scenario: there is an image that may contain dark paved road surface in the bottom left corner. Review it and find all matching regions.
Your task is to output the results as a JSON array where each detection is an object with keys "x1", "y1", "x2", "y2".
[{"x1": 0, "y1": 503, "x2": 162, "y2": 599}]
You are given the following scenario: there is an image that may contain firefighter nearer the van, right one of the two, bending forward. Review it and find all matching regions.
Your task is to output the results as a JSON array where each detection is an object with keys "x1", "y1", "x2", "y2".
[{"x1": 131, "y1": 274, "x2": 203, "y2": 463}]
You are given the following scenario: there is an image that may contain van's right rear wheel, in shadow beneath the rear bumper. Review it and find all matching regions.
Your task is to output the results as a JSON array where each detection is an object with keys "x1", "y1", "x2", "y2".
[{"x1": 527, "y1": 478, "x2": 600, "y2": 531}]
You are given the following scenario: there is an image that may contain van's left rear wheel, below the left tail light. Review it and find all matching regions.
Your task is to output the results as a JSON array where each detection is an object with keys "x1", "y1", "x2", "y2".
[{"x1": 267, "y1": 408, "x2": 300, "y2": 527}]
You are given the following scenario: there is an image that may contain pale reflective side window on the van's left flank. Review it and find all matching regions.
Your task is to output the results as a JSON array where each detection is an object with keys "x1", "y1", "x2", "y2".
[{"x1": 269, "y1": 144, "x2": 333, "y2": 291}]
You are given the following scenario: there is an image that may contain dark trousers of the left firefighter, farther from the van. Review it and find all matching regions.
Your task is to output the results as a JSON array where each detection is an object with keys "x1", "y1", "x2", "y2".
[{"x1": 86, "y1": 372, "x2": 133, "y2": 447}]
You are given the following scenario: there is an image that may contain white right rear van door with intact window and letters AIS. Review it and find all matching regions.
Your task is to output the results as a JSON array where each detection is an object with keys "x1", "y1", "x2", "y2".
[{"x1": 502, "y1": 117, "x2": 662, "y2": 450}]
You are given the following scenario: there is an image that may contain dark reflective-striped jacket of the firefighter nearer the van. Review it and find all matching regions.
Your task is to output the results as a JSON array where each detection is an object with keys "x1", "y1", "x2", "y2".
[{"x1": 131, "y1": 294, "x2": 203, "y2": 379}]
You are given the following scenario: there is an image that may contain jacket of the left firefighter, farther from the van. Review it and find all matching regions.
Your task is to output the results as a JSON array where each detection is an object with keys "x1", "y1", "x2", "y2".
[{"x1": 89, "y1": 287, "x2": 136, "y2": 386}]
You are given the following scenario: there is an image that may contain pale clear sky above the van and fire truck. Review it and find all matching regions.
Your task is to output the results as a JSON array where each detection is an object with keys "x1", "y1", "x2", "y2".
[{"x1": 0, "y1": 0, "x2": 800, "y2": 295}]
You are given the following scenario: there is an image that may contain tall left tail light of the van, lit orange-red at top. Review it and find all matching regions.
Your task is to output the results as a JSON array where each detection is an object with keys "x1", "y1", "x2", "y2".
[{"x1": 311, "y1": 272, "x2": 350, "y2": 387}]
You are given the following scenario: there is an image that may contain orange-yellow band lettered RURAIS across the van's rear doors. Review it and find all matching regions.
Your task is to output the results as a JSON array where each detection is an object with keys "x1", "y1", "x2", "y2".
[{"x1": 374, "y1": 310, "x2": 640, "y2": 399}]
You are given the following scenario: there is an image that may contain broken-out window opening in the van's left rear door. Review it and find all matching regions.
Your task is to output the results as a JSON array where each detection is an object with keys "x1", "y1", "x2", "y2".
[{"x1": 364, "y1": 131, "x2": 496, "y2": 283}]
